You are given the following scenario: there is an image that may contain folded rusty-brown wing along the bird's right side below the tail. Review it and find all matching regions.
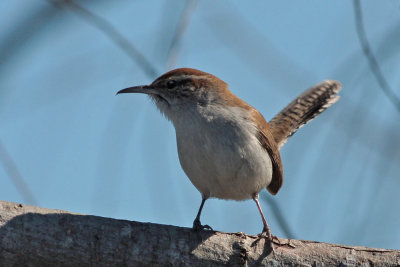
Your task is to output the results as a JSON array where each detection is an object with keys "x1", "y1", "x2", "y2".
[{"x1": 253, "y1": 109, "x2": 283, "y2": 195}]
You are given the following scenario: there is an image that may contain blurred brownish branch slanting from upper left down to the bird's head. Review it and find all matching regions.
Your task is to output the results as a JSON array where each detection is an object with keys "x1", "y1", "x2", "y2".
[{"x1": 47, "y1": 0, "x2": 159, "y2": 79}]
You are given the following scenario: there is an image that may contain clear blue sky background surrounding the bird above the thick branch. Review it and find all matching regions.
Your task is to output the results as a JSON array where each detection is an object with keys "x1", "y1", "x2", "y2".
[{"x1": 0, "y1": 0, "x2": 400, "y2": 249}]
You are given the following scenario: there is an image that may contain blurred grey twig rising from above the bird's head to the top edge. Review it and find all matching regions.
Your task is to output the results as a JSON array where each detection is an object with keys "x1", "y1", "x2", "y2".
[{"x1": 167, "y1": 0, "x2": 198, "y2": 69}]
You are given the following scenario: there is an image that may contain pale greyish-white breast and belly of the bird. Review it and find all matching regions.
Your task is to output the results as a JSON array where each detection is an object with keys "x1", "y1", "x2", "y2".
[{"x1": 169, "y1": 105, "x2": 272, "y2": 200}]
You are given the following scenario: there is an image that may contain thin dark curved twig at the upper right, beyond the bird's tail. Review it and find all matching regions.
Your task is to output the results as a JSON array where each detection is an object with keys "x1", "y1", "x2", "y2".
[{"x1": 353, "y1": 0, "x2": 400, "y2": 112}]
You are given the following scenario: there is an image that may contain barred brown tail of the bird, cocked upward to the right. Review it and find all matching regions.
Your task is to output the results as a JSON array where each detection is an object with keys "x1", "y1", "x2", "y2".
[{"x1": 269, "y1": 80, "x2": 342, "y2": 148}]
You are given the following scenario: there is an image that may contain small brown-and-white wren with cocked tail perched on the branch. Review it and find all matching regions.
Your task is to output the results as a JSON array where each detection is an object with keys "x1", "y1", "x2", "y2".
[{"x1": 117, "y1": 68, "x2": 341, "y2": 245}]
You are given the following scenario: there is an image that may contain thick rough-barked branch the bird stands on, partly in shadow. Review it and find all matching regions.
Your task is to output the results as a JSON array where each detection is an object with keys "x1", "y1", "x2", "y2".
[{"x1": 0, "y1": 201, "x2": 400, "y2": 266}]
